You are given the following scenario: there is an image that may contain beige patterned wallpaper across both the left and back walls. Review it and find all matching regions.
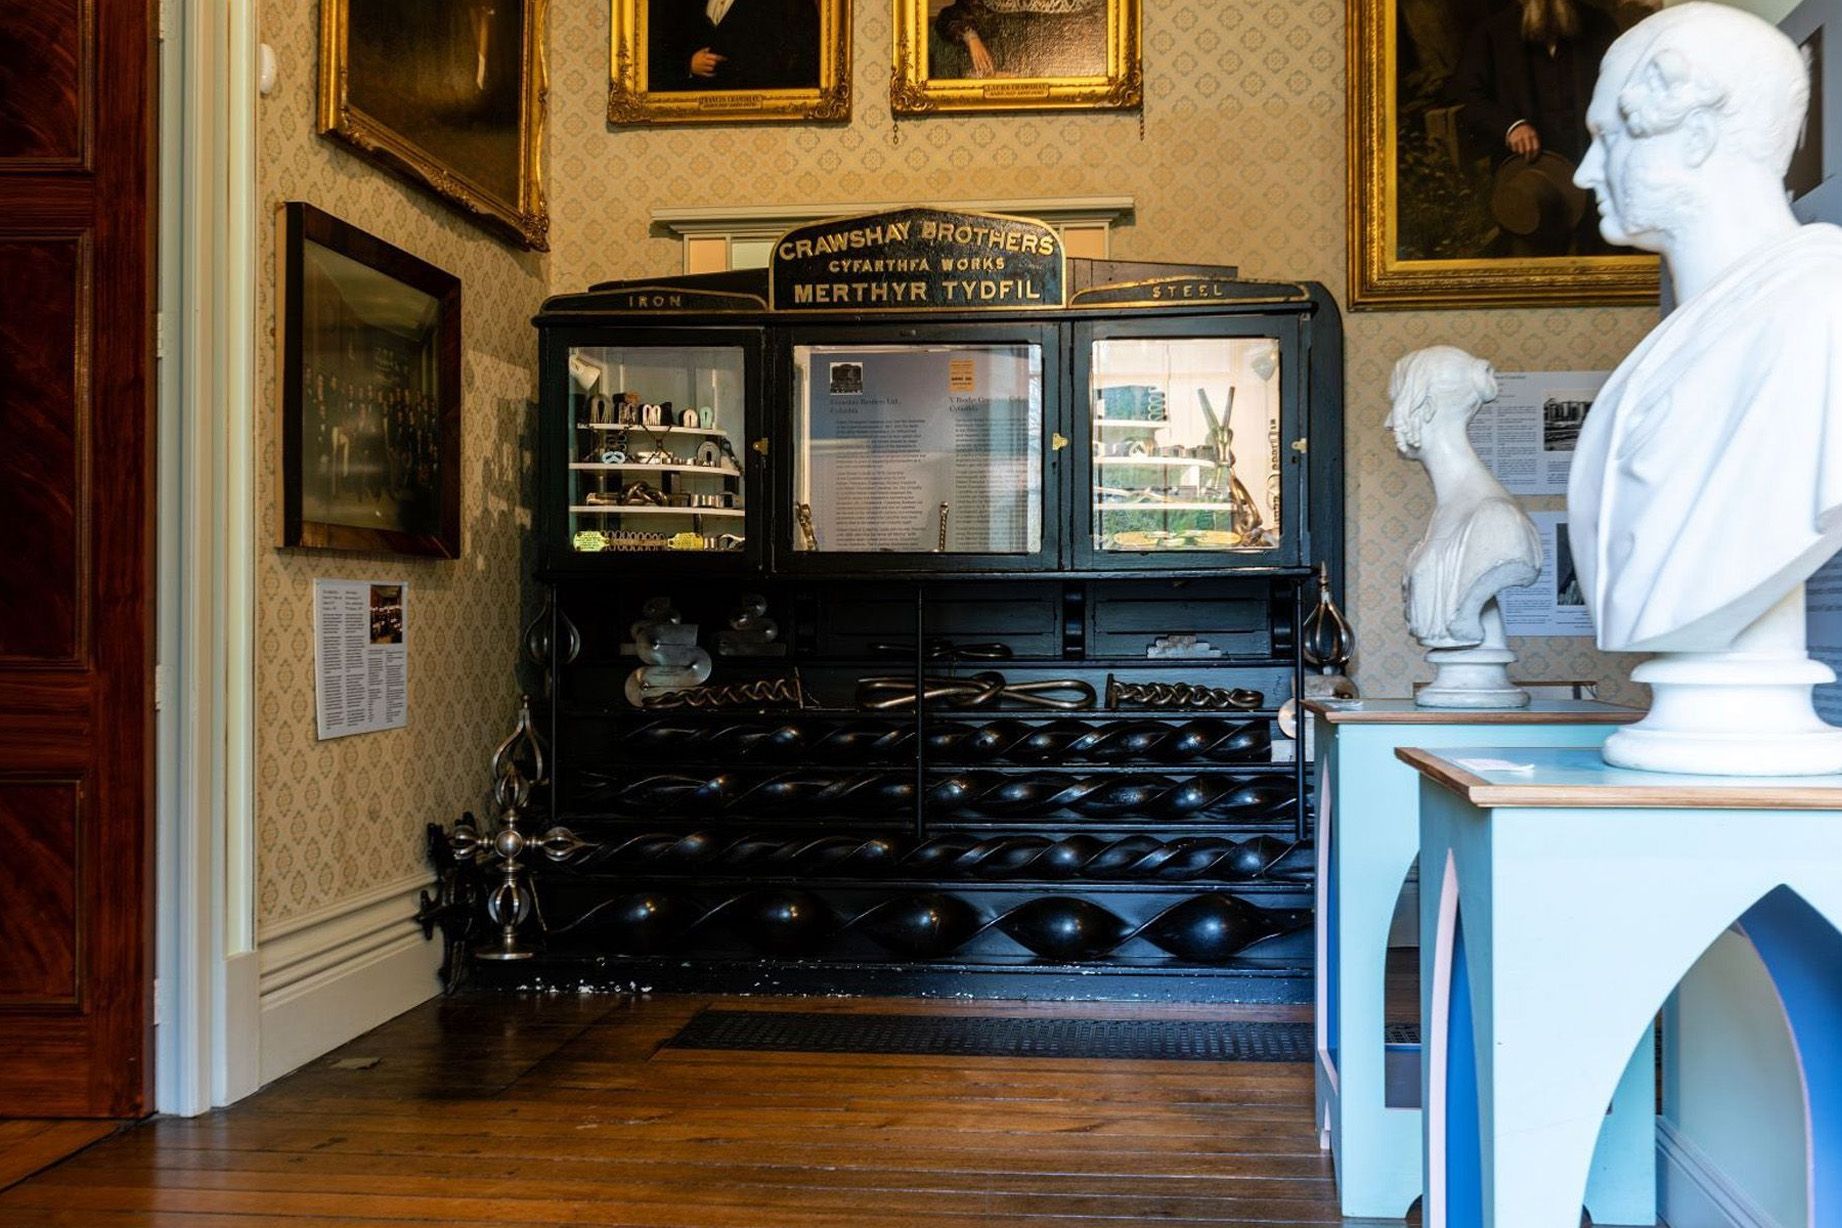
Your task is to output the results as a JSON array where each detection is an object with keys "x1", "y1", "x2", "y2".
[{"x1": 258, "y1": 0, "x2": 1652, "y2": 922}]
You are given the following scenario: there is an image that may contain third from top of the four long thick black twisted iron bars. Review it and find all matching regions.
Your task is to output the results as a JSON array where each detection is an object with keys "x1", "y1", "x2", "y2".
[{"x1": 573, "y1": 830, "x2": 1310, "y2": 882}]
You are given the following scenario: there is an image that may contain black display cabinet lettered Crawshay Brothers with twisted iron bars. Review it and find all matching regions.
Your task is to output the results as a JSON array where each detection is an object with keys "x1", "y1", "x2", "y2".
[{"x1": 497, "y1": 210, "x2": 1343, "y2": 1000}]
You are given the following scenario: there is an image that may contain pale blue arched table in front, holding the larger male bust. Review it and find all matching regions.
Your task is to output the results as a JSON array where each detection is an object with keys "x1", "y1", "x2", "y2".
[{"x1": 1400, "y1": 743, "x2": 1842, "y2": 1228}]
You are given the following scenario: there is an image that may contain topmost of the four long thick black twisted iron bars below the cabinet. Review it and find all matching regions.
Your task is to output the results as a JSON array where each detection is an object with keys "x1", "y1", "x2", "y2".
[{"x1": 623, "y1": 710, "x2": 1273, "y2": 766}]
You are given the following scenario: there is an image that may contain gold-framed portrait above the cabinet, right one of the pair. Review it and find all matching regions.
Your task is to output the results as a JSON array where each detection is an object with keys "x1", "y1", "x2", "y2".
[{"x1": 890, "y1": 0, "x2": 1144, "y2": 114}]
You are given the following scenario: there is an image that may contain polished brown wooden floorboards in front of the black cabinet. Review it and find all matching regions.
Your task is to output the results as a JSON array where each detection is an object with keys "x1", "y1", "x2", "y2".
[{"x1": 0, "y1": 996, "x2": 1407, "y2": 1228}]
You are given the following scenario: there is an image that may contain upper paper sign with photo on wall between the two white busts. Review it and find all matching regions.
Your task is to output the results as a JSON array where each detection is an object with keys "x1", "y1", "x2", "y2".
[{"x1": 1470, "y1": 370, "x2": 1610, "y2": 495}]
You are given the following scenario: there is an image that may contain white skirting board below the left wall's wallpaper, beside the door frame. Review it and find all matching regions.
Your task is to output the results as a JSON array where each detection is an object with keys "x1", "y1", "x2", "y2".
[{"x1": 256, "y1": 876, "x2": 442, "y2": 1083}]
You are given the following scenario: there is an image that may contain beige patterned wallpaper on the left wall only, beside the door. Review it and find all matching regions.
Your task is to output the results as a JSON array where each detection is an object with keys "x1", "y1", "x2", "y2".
[{"x1": 256, "y1": 0, "x2": 545, "y2": 926}]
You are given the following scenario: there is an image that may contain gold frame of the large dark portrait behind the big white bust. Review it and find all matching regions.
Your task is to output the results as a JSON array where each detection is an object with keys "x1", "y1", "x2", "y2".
[{"x1": 1348, "y1": 0, "x2": 1658, "y2": 309}]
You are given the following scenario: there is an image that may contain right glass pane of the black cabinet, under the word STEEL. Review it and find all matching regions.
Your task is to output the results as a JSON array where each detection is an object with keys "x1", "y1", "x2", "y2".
[{"x1": 1092, "y1": 337, "x2": 1280, "y2": 550}]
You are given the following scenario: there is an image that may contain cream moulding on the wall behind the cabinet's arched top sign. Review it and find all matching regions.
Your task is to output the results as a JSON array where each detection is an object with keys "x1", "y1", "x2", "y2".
[{"x1": 652, "y1": 195, "x2": 1138, "y2": 272}]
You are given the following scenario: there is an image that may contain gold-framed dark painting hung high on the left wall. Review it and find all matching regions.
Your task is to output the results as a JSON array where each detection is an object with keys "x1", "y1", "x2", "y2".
[{"x1": 319, "y1": 0, "x2": 551, "y2": 250}]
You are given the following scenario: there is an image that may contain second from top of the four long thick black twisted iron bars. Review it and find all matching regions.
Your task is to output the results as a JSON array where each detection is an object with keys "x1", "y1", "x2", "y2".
[{"x1": 582, "y1": 771, "x2": 1295, "y2": 821}]
